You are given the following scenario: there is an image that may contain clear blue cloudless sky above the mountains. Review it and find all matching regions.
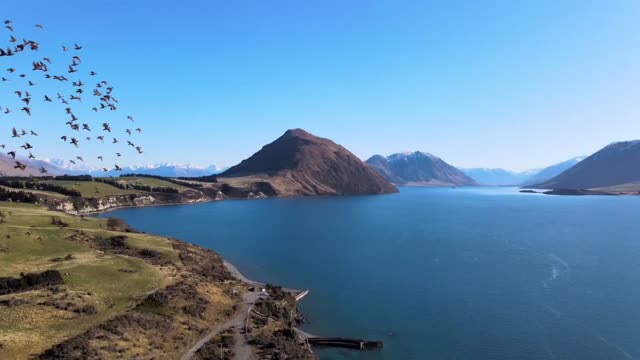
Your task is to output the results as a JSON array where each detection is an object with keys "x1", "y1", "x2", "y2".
[{"x1": 0, "y1": 0, "x2": 640, "y2": 170}]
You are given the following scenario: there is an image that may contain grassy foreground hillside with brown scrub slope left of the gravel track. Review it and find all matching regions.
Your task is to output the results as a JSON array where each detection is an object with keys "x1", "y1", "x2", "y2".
[{"x1": 0, "y1": 201, "x2": 237, "y2": 359}]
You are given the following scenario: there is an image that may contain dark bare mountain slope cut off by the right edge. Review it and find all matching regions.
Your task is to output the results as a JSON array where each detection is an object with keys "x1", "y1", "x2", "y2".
[{"x1": 532, "y1": 140, "x2": 640, "y2": 190}]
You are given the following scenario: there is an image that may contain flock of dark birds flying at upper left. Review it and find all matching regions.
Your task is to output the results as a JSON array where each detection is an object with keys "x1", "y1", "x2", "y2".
[{"x1": 0, "y1": 20, "x2": 143, "y2": 174}]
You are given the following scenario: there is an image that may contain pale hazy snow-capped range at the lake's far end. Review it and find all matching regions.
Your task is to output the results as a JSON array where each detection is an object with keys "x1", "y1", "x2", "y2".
[{"x1": 460, "y1": 156, "x2": 585, "y2": 186}]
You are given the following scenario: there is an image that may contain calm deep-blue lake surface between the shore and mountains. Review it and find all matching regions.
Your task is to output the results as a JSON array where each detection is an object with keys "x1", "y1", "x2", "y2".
[{"x1": 102, "y1": 188, "x2": 640, "y2": 360}]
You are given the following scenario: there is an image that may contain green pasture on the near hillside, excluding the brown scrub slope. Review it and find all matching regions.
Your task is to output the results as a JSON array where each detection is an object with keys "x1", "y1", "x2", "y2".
[{"x1": 0, "y1": 202, "x2": 179, "y2": 359}]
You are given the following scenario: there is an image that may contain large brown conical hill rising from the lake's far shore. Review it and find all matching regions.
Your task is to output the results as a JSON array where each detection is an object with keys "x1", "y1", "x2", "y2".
[{"x1": 220, "y1": 129, "x2": 397, "y2": 195}]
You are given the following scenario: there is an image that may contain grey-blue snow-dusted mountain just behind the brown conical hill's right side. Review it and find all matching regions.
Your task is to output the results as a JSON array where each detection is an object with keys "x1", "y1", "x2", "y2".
[{"x1": 367, "y1": 151, "x2": 477, "y2": 186}]
